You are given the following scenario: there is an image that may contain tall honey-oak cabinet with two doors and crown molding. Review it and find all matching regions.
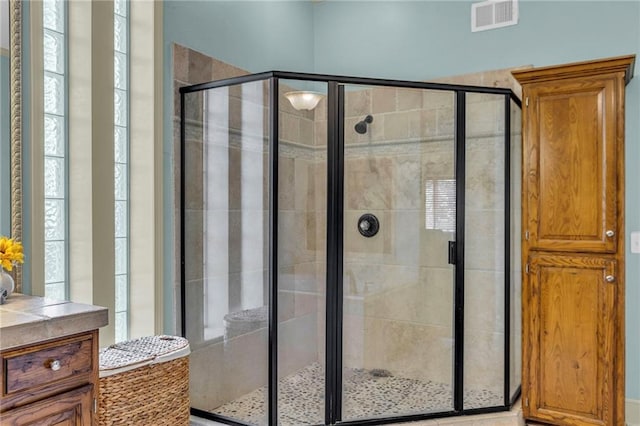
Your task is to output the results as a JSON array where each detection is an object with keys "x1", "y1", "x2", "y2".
[{"x1": 514, "y1": 56, "x2": 635, "y2": 426}]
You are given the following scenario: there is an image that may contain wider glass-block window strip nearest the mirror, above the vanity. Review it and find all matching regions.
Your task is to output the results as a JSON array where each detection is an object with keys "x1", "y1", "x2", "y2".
[{"x1": 42, "y1": 0, "x2": 68, "y2": 300}]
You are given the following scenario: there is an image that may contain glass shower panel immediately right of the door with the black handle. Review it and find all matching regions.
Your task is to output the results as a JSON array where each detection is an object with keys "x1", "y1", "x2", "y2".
[{"x1": 463, "y1": 93, "x2": 506, "y2": 409}]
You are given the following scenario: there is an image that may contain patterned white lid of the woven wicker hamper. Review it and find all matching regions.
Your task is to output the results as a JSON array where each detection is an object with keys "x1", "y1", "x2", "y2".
[{"x1": 100, "y1": 335, "x2": 189, "y2": 372}]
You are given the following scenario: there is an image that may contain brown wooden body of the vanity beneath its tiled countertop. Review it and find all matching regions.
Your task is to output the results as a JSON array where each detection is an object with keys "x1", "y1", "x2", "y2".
[{"x1": 0, "y1": 331, "x2": 98, "y2": 426}]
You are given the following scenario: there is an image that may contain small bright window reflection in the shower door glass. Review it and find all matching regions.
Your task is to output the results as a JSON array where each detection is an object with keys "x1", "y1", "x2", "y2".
[{"x1": 424, "y1": 179, "x2": 456, "y2": 232}]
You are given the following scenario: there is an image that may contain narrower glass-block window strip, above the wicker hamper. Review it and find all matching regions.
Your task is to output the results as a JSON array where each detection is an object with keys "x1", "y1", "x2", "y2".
[{"x1": 113, "y1": 0, "x2": 129, "y2": 342}]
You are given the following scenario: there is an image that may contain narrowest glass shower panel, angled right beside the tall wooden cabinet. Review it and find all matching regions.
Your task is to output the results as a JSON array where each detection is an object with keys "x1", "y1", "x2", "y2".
[{"x1": 509, "y1": 101, "x2": 522, "y2": 398}]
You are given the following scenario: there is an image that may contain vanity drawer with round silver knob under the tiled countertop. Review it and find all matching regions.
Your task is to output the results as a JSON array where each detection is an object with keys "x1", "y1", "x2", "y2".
[{"x1": 2, "y1": 334, "x2": 94, "y2": 395}]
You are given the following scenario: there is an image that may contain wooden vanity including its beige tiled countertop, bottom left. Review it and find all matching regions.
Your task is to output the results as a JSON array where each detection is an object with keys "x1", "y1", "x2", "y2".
[{"x1": 0, "y1": 294, "x2": 108, "y2": 426}]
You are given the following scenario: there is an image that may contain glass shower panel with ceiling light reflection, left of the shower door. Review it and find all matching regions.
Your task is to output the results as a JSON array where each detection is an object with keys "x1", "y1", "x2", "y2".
[{"x1": 278, "y1": 80, "x2": 327, "y2": 426}]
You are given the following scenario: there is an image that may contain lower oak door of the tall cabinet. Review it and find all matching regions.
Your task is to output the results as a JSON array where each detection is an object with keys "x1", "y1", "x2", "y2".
[{"x1": 523, "y1": 254, "x2": 618, "y2": 426}]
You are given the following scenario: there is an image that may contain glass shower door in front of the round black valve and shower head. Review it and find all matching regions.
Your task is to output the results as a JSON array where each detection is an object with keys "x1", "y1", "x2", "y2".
[{"x1": 342, "y1": 86, "x2": 456, "y2": 421}]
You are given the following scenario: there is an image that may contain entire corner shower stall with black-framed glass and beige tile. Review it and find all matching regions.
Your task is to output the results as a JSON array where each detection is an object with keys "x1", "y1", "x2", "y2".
[{"x1": 180, "y1": 71, "x2": 521, "y2": 426}]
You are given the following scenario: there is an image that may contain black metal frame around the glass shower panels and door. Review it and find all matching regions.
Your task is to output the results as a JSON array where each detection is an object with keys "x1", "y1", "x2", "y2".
[{"x1": 180, "y1": 71, "x2": 522, "y2": 426}]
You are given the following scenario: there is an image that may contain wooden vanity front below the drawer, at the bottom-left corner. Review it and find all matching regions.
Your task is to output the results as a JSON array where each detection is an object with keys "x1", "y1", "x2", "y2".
[{"x1": 0, "y1": 385, "x2": 93, "y2": 426}]
